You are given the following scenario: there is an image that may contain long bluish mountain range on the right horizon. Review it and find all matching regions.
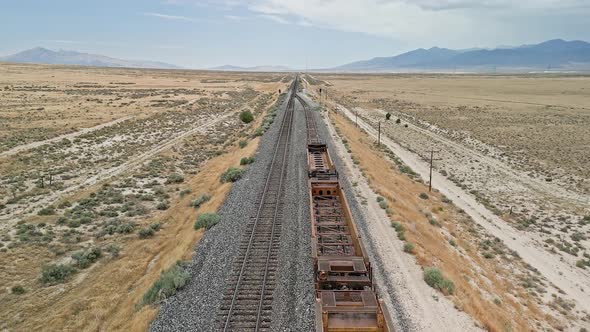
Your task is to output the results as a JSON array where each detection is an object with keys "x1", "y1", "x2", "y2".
[{"x1": 336, "y1": 39, "x2": 590, "y2": 72}]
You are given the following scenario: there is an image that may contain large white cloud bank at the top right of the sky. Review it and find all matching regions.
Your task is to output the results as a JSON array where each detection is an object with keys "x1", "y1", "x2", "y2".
[{"x1": 247, "y1": 0, "x2": 590, "y2": 47}]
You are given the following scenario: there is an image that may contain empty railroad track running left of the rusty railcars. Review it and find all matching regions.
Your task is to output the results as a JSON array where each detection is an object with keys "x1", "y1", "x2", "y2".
[{"x1": 217, "y1": 78, "x2": 298, "y2": 331}]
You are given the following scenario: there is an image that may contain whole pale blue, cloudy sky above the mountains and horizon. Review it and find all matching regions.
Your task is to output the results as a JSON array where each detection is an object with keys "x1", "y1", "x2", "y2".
[{"x1": 0, "y1": 0, "x2": 590, "y2": 69}]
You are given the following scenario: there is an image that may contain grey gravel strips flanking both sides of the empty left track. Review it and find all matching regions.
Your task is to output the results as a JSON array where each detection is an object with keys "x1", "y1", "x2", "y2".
[{"x1": 150, "y1": 88, "x2": 314, "y2": 331}]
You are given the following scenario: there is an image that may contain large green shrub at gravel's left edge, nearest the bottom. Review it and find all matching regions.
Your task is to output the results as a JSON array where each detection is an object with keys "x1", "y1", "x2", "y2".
[{"x1": 141, "y1": 262, "x2": 190, "y2": 305}]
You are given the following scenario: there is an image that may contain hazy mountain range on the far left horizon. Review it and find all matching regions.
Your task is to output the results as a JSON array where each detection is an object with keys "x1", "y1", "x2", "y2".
[{"x1": 0, "y1": 47, "x2": 180, "y2": 69}]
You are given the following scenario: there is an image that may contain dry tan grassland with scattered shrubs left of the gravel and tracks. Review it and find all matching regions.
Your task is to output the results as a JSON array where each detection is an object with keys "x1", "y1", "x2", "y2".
[{"x1": 0, "y1": 64, "x2": 290, "y2": 331}]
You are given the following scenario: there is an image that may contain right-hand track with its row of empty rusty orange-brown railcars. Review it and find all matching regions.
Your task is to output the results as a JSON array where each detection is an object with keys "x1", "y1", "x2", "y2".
[{"x1": 296, "y1": 91, "x2": 393, "y2": 332}]
